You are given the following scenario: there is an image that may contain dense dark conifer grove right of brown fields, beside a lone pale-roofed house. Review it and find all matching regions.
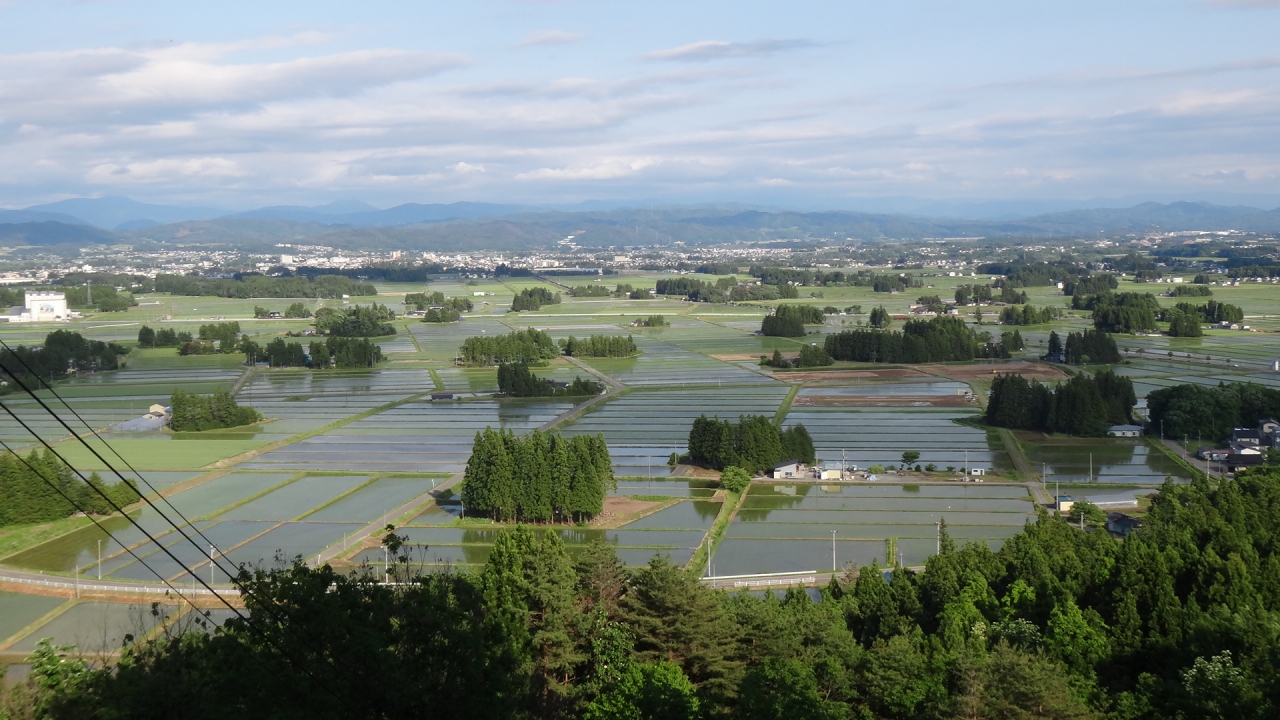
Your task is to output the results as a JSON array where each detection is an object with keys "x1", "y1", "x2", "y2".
[{"x1": 986, "y1": 370, "x2": 1138, "y2": 437}]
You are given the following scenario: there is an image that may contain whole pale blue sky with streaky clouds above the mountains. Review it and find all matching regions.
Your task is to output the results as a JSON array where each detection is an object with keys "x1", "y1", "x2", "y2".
[{"x1": 0, "y1": 0, "x2": 1280, "y2": 209}]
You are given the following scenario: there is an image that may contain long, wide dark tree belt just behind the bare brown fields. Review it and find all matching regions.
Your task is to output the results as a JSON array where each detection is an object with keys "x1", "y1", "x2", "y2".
[{"x1": 824, "y1": 311, "x2": 1004, "y2": 363}]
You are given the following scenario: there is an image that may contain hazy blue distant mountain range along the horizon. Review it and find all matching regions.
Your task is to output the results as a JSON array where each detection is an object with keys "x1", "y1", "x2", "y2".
[{"x1": 0, "y1": 197, "x2": 1280, "y2": 251}]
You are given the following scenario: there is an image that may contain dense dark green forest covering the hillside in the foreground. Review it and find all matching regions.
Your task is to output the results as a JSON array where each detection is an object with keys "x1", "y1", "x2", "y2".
[{"x1": 23, "y1": 469, "x2": 1280, "y2": 720}]
